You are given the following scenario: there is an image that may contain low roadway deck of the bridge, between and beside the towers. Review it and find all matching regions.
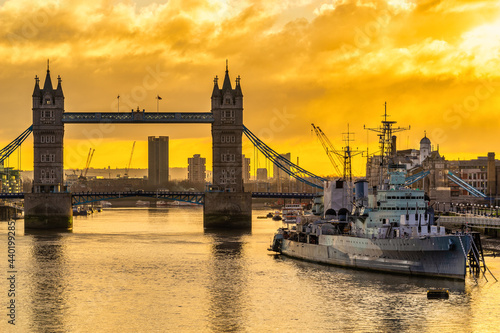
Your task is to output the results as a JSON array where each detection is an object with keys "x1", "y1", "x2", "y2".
[{"x1": 0, "y1": 190, "x2": 314, "y2": 205}]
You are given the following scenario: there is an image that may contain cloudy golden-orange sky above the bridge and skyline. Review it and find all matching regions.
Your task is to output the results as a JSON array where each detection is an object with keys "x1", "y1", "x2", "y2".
[{"x1": 0, "y1": 0, "x2": 500, "y2": 175}]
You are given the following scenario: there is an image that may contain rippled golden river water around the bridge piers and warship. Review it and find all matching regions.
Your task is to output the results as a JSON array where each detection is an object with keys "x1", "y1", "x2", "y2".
[{"x1": 0, "y1": 207, "x2": 500, "y2": 332}]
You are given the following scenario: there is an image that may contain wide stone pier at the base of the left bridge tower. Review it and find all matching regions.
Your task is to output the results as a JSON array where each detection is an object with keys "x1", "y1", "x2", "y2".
[{"x1": 24, "y1": 193, "x2": 73, "y2": 230}]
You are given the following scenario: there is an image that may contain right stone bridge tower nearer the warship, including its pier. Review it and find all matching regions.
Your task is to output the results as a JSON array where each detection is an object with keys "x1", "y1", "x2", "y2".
[{"x1": 204, "y1": 61, "x2": 252, "y2": 229}]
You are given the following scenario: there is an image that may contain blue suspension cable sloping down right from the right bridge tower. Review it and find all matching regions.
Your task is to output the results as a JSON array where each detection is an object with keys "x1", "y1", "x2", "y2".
[{"x1": 243, "y1": 126, "x2": 326, "y2": 189}]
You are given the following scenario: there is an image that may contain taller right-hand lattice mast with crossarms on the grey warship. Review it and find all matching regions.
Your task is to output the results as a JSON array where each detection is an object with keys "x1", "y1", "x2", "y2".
[{"x1": 364, "y1": 102, "x2": 410, "y2": 185}]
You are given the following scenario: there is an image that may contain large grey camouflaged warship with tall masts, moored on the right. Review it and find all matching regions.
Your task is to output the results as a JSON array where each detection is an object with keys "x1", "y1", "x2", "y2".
[{"x1": 269, "y1": 109, "x2": 486, "y2": 280}]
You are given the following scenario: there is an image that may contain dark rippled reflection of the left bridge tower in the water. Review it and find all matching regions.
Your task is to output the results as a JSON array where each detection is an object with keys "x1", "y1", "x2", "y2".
[{"x1": 30, "y1": 232, "x2": 67, "y2": 332}]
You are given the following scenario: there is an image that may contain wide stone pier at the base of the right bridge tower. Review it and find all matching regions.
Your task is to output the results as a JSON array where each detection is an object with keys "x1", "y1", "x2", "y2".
[{"x1": 203, "y1": 192, "x2": 252, "y2": 229}]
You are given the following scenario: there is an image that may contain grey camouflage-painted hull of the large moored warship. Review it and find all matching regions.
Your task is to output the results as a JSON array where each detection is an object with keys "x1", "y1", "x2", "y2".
[{"x1": 281, "y1": 235, "x2": 470, "y2": 280}]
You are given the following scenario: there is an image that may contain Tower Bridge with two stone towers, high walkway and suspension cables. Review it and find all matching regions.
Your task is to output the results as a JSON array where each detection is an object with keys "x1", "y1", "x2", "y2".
[{"x1": 11, "y1": 63, "x2": 324, "y2": 229}]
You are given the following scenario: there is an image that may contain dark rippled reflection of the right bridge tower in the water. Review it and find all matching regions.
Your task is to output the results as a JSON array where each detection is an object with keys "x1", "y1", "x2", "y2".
[{"x1": 205, "y1": 231, "x2": 250, "y2": 332}]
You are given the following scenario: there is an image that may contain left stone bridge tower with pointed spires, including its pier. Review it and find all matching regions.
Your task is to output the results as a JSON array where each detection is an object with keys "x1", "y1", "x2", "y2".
[{"x1": 25, "y1": 63, "x2": 73, "y2": 229}]
